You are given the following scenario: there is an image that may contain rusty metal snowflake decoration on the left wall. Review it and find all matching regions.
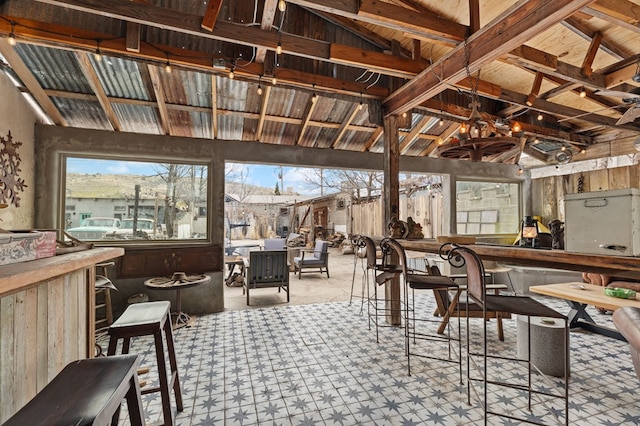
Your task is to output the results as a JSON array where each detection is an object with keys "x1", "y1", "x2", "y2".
[{"x1": 0, "y1": 131, "x2": 27, "y2": 207}]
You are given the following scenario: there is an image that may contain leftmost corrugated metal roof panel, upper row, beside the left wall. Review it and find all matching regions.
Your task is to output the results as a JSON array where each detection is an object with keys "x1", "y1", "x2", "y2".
[{"x1": 16, "y1": 43, "x2": 93, "y2": 93}]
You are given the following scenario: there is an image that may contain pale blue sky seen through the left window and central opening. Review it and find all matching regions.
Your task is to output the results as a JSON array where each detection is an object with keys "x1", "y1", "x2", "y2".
[{"x1": 67, "y1": 158, "x2": 319, "y2": 195}]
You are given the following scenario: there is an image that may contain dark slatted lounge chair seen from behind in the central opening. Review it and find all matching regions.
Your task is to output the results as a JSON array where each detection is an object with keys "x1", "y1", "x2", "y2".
[{"x1": 242, "y1": 250, "x2": 290, "y2": 305}]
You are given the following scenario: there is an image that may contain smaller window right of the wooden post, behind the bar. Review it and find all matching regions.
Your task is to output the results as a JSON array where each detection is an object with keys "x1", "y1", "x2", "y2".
[{"x1": 456, "y1": 181, "x2": 521, "y2": 235}]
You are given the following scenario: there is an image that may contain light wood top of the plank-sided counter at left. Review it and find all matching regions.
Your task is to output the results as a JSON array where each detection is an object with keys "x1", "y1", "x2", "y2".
[{"x1": 0, "y1": 247, "x2": 124, "y2": 297}]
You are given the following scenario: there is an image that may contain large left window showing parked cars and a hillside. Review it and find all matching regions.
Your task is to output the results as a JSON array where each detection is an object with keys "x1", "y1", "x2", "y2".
[{"x1": 64, "y1": 157, "x2": 208, "y2": 242}]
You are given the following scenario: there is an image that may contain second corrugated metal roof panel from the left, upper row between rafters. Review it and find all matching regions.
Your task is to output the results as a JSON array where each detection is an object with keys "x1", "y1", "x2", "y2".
[{"x1": 89, "y1": 55, "x2": 152, "y2": 101}]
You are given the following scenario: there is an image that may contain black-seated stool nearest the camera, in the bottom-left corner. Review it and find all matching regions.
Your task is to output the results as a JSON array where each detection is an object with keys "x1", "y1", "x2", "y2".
[{"x1": 3, "y1": 355, "x2": 145, "y2": 426}]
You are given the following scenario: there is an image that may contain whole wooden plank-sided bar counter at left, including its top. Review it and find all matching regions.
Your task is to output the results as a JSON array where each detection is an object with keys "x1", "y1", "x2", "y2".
[{"x1": 0, "y1": 248, "x2": 124, "y2": 423}]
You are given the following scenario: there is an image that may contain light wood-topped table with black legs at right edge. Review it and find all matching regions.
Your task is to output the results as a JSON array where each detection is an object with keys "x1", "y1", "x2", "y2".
[{"x1": 529, "y1": 282, "x2": 640, "y2": 341}]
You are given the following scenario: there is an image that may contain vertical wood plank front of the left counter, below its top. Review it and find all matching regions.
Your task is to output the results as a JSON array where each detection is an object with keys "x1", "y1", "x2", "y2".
[{"x1": 0, "y1": 268, "x2": 93, "y2": 423}]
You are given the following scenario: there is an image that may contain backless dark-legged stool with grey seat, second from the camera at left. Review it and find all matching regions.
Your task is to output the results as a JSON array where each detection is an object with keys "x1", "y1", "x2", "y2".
[{"x1": 107, "y1": 301, "x2": 183, "y2": 425}]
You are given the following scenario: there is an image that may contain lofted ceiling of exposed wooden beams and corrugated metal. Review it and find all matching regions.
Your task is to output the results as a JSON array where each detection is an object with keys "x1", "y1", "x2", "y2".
[{"x1": 0, "y1": 0, "x2": 640, "y2": 166}]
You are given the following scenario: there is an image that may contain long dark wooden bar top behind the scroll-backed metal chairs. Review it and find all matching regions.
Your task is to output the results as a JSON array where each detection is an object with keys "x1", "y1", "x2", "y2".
[{"x1": 398, "y1": 239, "x2": 640, "y2": 281}]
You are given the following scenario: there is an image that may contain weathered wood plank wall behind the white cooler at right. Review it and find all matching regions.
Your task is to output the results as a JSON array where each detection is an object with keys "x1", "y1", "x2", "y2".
[{"x1": 531, "y1": 165, "x2": 640, "y2": 224}]
